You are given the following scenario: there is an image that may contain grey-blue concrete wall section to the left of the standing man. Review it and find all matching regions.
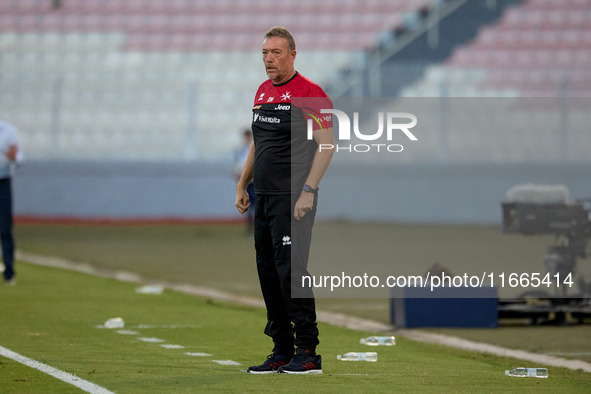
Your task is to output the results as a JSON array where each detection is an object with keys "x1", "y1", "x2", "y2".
[{"x1": 13, "y1": 161, "x2": 238, "y2": 220}]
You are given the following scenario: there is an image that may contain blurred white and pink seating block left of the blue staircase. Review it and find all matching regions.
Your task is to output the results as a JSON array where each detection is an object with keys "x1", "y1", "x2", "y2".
[{"x1": 0, "y1": 0, "x2": 429, "y2": 160}]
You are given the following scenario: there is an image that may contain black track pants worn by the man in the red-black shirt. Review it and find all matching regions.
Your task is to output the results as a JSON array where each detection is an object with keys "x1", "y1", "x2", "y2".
[{"x1": 255, "y1": 194, "x2": 318, "y2": 353}]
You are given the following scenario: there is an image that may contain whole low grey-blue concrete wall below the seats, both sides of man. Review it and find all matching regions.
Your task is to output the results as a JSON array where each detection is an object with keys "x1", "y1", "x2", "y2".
[{"x1": 13, "y1": 161, "x2": 591, "y2": 224}]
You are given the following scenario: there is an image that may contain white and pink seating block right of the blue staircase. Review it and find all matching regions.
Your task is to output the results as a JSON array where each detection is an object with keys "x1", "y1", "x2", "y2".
[{"x1": 394, "y1": 0, "x2": 591, "y2": 163}]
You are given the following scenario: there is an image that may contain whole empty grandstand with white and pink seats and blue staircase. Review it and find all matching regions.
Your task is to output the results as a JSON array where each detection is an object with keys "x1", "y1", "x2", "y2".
[{"x1": 0, "y1": 0, "x2": 591, "y2": 162}]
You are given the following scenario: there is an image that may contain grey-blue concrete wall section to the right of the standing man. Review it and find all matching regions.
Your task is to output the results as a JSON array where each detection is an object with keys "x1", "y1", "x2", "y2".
[{"x1": 319, "y1": 163, "x2": 591, "y2": 224}]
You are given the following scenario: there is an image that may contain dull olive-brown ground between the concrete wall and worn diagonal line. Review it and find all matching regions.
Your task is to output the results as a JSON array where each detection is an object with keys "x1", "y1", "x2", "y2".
[{"x1": 15, "y1": 222, "x2": 591, "y2": 362}]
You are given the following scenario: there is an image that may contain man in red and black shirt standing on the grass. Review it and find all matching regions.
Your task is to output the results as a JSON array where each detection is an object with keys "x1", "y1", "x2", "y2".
[{"x1": 235, "y1": 27, "x2": 334, "y2": 374}]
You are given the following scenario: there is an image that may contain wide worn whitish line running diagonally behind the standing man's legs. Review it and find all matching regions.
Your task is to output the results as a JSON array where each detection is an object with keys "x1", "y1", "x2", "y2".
[{"x1": 16, "y1": 250, "x2": 591, "y2": 372}]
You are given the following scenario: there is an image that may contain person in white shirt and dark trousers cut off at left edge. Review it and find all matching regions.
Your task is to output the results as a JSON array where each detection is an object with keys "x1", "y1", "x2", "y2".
[{"x1": 0, "y1": 120, "x2": 24, "y2": 285}]
